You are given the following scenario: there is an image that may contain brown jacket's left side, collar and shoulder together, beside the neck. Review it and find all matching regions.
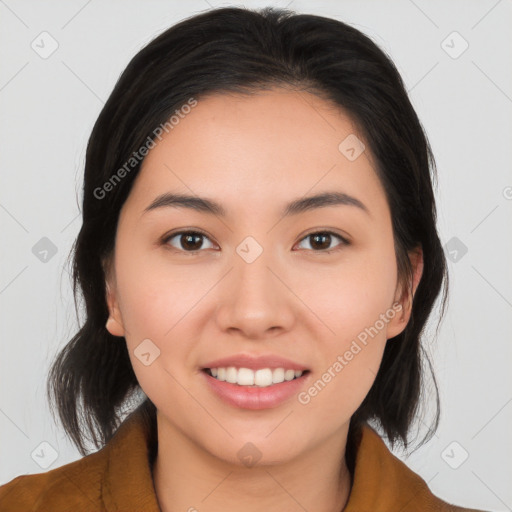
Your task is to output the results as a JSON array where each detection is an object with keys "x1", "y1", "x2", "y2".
[{"x1": 0, "y1": 408, "x2": 159, "y2": 512}]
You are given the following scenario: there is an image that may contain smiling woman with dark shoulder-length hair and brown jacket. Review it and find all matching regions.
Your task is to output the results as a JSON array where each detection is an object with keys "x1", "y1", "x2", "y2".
[{"x1": 0, "y1": 8, "x2": 484, "y2": 512}]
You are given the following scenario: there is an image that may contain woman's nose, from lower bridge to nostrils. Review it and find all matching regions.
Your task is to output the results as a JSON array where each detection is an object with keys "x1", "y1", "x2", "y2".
[{"x1": 216, "y1": 244, "x2": 300, "y2": 340}]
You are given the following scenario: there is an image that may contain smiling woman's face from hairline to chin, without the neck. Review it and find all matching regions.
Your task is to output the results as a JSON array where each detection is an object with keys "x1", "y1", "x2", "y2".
[{"x1": 103, "y1": 90, "x2": 421, "y2": 464}]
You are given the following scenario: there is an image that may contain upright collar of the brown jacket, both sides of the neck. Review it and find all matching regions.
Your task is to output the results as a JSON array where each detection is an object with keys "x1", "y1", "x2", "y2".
[{"x1": 102, "y1": 410, "x2": 448, "y2": 512}]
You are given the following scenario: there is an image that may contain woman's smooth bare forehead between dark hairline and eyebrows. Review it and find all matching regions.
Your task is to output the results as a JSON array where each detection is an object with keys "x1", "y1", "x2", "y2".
[{"x1": 121, "y1": 89, "x2": 379, "y2": 220}]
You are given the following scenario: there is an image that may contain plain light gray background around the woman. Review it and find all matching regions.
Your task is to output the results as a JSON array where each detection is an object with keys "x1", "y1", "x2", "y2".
[{"x1": 0, "y1": 0, "x2": 512, "y2": 511}]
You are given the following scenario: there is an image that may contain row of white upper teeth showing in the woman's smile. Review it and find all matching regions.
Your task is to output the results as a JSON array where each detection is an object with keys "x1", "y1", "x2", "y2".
[{"x1": 209, "y1": 366, "x2": 304, "y2": 388}]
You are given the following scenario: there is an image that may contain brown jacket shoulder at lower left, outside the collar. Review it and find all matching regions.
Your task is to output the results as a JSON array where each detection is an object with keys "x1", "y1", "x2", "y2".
[{"x1": 0, "y1": 449, "x2": 108, "y2": 512}]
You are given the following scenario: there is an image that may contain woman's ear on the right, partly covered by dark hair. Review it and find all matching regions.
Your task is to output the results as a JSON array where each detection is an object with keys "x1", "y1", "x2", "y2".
[{"x1": 386, "y1": 247, "x2": 423, "y2": 339}]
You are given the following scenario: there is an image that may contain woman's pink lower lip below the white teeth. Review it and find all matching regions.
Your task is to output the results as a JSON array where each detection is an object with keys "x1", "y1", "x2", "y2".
[{"x1": 201, "y1": 371, "x2": 310, "y2": 410}]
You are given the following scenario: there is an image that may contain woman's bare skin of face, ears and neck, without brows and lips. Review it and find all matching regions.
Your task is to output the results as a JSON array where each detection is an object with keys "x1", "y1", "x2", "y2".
[{"x1": 103, "y1": 89, "x2": 422, "y2": 512}]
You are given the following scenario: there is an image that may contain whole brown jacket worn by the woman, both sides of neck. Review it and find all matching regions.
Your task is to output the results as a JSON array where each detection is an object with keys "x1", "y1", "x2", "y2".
[{"x1": 0, "y1": 410, "x2": 482, "y2": 512}]
